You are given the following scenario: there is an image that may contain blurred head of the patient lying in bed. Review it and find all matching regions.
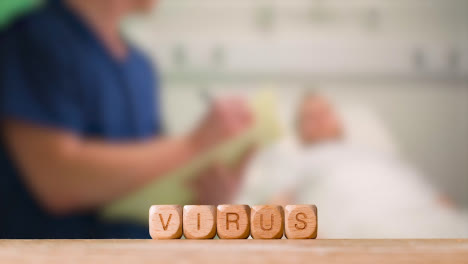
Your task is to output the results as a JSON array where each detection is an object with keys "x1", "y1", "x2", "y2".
[{"x1": 296, "y1": 94, "x2": 343, "y2": 144}]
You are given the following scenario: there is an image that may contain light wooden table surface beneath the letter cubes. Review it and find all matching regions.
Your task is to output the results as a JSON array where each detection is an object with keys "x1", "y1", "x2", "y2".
[{"x1": 0, "y1": 239, "x2": 468, "y2": 264}]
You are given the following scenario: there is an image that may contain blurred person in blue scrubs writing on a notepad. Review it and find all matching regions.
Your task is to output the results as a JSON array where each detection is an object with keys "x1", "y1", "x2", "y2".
[{"x1": 0, "y1": 0, "x2": 251, "y2": 238}]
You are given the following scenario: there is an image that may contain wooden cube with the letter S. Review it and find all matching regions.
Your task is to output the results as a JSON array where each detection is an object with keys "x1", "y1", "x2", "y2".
[{"x1": 285, "y1": 205, "x2": 317, "y2": 239}]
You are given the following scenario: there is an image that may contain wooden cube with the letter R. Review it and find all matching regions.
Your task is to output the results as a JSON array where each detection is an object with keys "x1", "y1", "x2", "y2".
[{"x1": 217, "y1": 205, "x2": 250, "y2": 239}]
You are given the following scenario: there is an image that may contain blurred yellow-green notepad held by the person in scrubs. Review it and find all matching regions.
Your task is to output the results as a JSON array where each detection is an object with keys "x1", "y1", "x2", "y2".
[{"x1": 101, "y1": 91, "x2": 281, "y2": 223}]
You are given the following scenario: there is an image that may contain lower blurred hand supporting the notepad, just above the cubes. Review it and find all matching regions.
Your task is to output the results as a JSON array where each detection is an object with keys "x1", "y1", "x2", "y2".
[{"x1": 189, "y1": 147, "x2": 255, "y2": 205}]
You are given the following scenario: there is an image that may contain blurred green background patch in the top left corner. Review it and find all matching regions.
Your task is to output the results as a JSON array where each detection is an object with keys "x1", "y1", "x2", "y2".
[{"x1": 0, "y1": 0, "x2": 43, "y2": 29}]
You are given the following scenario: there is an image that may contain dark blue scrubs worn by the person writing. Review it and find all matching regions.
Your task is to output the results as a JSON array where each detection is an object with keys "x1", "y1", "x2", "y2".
[{"x1": 0, "y1": 1, "x2": 160, "y2": 238}]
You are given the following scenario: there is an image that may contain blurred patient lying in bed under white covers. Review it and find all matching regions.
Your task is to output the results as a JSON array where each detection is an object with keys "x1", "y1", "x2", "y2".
[{"x1": 238, "y1": 94, "x2": 468, "y2": 238}]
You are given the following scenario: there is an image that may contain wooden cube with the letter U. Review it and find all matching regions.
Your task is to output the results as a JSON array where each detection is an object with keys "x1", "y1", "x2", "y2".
[{"x1": 250, "y1": 205, "x2": 284, "y2": 239}]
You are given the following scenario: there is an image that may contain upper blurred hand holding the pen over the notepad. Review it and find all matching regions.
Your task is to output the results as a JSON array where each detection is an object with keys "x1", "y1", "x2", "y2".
[{"x1": 190, "y1": 97, "x2": 253, "y2": 150}]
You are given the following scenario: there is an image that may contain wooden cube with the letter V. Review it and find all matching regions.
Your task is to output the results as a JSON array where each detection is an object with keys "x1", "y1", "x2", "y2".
[{"x1": 149, "y1": 205, "x2": 182, "y2": 239}]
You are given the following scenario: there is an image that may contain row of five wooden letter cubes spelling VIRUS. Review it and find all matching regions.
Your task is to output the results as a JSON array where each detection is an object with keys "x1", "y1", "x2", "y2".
[{"x1": 149, "y1": 205, "x2": 317, "y2": 239}]
